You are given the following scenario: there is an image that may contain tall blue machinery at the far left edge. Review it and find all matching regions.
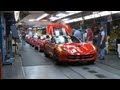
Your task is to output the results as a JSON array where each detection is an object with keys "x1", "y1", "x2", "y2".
[{"x1": 0, "y1": 13, "x2": 14, "y2": 64}]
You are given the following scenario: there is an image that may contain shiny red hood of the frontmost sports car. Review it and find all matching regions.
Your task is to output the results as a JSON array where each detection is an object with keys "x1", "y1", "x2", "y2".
[{"x1": 61, "y1": 43, "x2": 95, "y2": 55}]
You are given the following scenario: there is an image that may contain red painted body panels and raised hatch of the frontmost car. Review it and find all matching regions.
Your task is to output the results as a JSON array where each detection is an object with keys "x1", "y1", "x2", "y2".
[{"x1": 44, "y1": 24, "x2": 97, "y2": 62}]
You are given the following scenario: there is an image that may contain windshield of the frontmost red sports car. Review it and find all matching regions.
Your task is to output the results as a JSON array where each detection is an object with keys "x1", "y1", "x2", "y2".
[{"x1": 55, "y1": 36, "x2": 80, "y2": 44}]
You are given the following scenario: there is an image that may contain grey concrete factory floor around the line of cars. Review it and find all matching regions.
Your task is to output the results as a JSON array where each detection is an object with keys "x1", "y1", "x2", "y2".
[{"x1": 2, "y1": 44, "x2": 120, "y2": 79}]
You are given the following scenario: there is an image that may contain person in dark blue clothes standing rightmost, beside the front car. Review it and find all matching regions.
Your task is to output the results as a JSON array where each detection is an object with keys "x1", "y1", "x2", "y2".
[{"x1": 97, "y1": 26, "x2": 106, "y2": 60}]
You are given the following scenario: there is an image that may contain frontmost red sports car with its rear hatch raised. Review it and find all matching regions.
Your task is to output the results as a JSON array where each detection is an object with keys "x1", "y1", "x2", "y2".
[{"x1": 44, "y1": 24, "x2": 97, "y2": 64}]
